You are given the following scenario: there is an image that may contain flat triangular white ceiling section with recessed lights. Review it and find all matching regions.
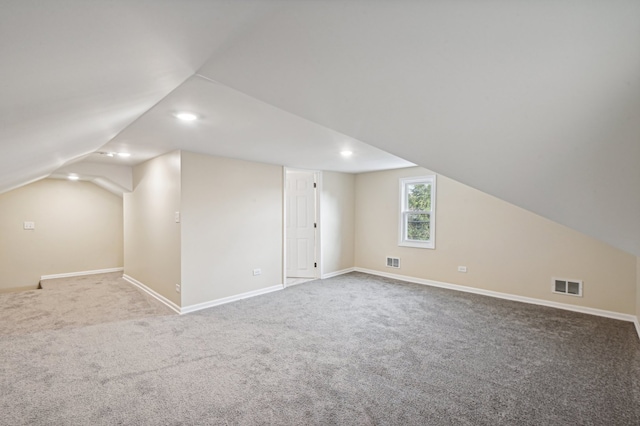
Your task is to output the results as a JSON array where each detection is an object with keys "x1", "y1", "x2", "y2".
[{"x1": 95, "y1": 75, "x2": 414, "y2": 173}]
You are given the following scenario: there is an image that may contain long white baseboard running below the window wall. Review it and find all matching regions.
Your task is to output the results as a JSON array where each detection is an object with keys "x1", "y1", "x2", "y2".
[{"x1": 355, "y1": 267, "x2": 640, "y2": 324}]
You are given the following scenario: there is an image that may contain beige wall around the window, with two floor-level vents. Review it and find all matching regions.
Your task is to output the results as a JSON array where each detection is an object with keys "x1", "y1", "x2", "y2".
[{"x1": 356, "y1": 167, "x2": 637, "y2": 315}]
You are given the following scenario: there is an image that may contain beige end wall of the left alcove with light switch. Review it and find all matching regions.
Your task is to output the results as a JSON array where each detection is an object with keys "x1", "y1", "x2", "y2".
[{"x1": 0, "y1": 179, "x2": 123, "y2": 291}]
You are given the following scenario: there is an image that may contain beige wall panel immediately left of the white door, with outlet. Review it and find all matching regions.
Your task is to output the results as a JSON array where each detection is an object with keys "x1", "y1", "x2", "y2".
[{"x1": 181, "y1": 151, "x2": 283, "y2": 306}]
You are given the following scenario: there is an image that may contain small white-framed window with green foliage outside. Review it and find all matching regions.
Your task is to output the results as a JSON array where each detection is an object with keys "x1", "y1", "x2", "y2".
[{"x1": 398, "y1": 176, "x2": 436, "y2": 249}]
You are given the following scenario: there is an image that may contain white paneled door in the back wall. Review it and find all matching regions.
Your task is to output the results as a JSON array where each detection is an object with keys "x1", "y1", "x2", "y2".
[{"x1": 286, "y1": 171, "x2": 317, "y2": 278}]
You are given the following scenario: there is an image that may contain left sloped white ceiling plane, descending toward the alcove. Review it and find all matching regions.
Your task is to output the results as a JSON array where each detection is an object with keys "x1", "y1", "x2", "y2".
[{"x1": 0, "y1": 0, "x2": 276, "y2": 190}]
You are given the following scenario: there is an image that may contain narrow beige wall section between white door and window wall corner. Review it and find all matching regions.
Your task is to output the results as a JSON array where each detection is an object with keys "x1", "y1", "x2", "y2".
[{"x1": 320, "y1": 172, "x2": 356, "y2": 276}]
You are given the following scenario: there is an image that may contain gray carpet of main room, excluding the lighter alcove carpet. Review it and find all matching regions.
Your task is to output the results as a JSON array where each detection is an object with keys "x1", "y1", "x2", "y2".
[{"x1": 0, "y1": 273, "x2": 640, "y2": 425}]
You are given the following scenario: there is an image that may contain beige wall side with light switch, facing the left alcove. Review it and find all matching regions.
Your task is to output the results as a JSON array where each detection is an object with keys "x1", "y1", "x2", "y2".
[{"x1": 124, "y1": 151, "x2": 182, "y2": 306}]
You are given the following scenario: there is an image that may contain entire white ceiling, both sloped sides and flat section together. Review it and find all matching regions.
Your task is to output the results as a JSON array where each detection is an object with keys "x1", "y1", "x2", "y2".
[{"x1": 0, "y1": 0, "x2": 640, "y2": 255}]
